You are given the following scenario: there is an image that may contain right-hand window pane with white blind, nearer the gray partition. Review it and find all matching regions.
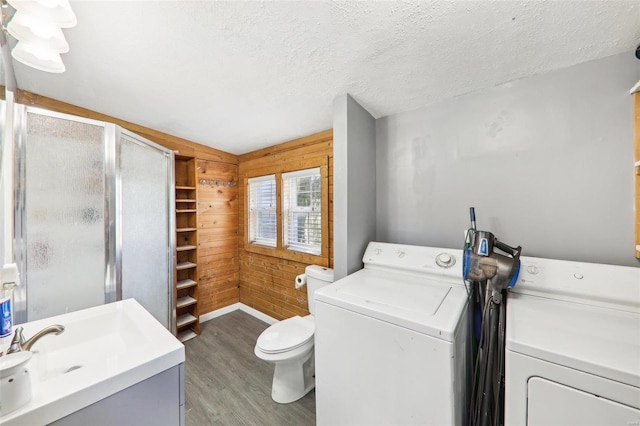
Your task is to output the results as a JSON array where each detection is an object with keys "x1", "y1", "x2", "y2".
[{"x1": 282, "y1": 167, "x2": 322, "y2": 255}]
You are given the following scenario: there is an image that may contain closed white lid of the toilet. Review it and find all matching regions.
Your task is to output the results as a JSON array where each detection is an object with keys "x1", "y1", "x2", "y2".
[{"x1": 257, "y1": 315, "x2": 315, "y2": 354}]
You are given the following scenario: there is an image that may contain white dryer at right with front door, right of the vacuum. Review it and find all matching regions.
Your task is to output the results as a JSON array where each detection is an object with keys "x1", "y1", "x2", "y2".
[{"x1": 505, "y1": 257, "x2": 640, "y2": 426}]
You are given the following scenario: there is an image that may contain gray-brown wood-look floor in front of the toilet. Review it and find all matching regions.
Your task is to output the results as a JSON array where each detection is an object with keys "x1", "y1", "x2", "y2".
[{"x1": 185, "y1": 311, "x2": 316, "y2": 426}]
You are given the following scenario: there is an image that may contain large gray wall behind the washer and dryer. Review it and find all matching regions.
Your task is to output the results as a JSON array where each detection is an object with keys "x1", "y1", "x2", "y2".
[{"x1": 376, "y1": 52, "x2": 640, "y2": 266}]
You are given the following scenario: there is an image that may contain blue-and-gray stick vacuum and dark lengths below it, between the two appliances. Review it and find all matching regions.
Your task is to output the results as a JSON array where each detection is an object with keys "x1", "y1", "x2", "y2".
[{"x1": 463, "y1": 207, "x2": 522, "y2": 426}]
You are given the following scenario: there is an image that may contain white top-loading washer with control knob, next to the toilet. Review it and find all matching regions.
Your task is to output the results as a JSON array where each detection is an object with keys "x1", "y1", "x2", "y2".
[{"x1": 315, "y1": 242, "x2": 469, "y2": 426}]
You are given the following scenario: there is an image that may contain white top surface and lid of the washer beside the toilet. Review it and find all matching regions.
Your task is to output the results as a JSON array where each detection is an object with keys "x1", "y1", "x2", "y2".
[{"x1": 315, "y1": 268, "x2": 467, "y2": 342}]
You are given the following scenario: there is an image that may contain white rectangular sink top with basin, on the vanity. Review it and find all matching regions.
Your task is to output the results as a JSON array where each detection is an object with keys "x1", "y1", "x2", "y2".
[{"x1": 0, "y1": 299, "x2": 185, "y2": 426}]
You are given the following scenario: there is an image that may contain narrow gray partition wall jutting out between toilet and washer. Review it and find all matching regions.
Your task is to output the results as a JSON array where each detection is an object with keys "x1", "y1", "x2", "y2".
[{"x1": 333, "y1": 95, "x2": 376, "y2": 279}]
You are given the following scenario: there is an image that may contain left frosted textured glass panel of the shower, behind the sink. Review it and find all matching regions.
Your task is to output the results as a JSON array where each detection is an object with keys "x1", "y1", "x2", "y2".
[{"x1": 24, "y1": 113, "x2": 106, "y2": 321}]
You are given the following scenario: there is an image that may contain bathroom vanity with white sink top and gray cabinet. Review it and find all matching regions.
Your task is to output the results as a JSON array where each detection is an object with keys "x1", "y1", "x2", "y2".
[{"x1": 0, "y1": 299, "x2": 185, "y2": 426}]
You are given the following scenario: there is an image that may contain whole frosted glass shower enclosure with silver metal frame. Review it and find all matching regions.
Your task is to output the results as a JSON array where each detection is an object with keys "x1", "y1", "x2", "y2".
[{"x1": 14, "y1": 105, "x2": 175, "y2": 330}]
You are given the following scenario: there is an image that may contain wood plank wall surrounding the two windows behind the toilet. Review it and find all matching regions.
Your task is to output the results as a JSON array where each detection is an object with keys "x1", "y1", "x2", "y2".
[{"x1": 238, "y1": 130, "x2": 333, "y2": 320}]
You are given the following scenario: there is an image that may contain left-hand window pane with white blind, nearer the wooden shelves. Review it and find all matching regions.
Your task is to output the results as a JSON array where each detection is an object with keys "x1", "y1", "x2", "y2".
[{"x1": 247, "y1": 175, "x2": 277, "y2": 247}]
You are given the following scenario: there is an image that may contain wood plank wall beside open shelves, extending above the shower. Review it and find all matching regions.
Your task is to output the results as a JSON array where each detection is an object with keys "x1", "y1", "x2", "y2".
[{"x1": 2, "y1": 88, "x2": 240, "y2": 315}]
